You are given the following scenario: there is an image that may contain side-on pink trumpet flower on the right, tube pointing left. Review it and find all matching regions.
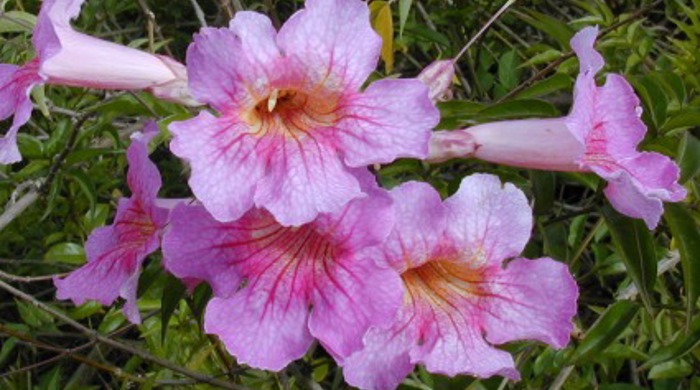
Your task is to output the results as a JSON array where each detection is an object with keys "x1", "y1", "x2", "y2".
[{"x1": 428, "y1": 27, "x2": 686, "y2": 229}]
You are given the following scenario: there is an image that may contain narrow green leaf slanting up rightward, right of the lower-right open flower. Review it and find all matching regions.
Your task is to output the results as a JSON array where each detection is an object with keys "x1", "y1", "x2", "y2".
[{"x1": 570, "y1": 301, "x2": 639, "y2": 364}]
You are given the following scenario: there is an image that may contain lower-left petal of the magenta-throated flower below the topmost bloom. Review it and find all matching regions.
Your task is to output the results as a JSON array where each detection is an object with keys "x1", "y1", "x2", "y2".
[{"x1": 204, "y1": 292, "x2": 313, "y2": 371}]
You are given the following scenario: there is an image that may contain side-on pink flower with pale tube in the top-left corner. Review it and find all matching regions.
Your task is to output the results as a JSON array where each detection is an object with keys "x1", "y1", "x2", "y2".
[{"x1": 0, "y1": 0, "x2": 199, "y2": 164}]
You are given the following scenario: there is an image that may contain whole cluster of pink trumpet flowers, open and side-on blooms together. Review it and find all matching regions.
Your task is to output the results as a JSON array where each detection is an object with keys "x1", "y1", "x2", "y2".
[{"x1": 0, "y1": 0, "x2": 685, "y2": 389}]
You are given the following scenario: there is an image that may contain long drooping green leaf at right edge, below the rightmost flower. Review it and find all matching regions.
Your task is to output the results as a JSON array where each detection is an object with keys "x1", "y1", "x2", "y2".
[{"x1": 664, "y1": 203, "x2": 700, "y2": 318}]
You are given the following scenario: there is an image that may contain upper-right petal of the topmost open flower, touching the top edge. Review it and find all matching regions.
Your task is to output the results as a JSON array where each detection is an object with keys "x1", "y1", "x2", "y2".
[{"x1": 277, "y1": 0, "x2": 382, "y2": 92}]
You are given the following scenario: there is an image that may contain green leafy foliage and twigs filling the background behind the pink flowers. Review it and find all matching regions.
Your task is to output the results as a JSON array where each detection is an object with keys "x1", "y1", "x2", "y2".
[{"x1": 0, "y1": 0, "x2": 700, "y2": 390}]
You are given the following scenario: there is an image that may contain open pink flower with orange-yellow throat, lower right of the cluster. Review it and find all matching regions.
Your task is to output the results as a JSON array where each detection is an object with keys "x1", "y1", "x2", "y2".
[{"x1": 343, "y1": 175, "x2": 578, "y2": 389}]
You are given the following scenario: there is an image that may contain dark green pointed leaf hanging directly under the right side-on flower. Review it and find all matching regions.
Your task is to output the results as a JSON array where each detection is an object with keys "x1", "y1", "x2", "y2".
[{"x1": 602, "y1": 205, "x2": 657, "y2": 311}]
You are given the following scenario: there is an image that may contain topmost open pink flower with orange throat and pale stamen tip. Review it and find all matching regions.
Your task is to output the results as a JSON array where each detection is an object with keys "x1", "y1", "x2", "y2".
[{"x1": 170, "y1": 0, "x2": 439, "y2": 225}]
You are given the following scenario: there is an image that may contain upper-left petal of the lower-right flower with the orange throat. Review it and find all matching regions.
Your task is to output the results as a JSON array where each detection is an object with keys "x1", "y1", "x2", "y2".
[{"x1": 375, "y1": 182, "x2": 447, "y2": 272}]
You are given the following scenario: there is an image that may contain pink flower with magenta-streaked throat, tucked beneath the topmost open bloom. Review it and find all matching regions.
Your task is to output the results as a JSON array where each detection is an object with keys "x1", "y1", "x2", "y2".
[{"x1": 163, "y1": 172, "x2": 401, "y2": 370}]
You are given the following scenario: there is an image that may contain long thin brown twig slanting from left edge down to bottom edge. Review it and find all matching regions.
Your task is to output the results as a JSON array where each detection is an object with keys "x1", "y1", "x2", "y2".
[{"x1": 0, "y1": 280, "x2": 245, "y2": 390}]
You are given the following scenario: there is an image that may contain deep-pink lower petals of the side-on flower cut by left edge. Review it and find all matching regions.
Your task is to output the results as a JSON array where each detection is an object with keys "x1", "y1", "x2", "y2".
[{"x1": 0, "y1": 60, "x2": 42, "y2": 164}]
